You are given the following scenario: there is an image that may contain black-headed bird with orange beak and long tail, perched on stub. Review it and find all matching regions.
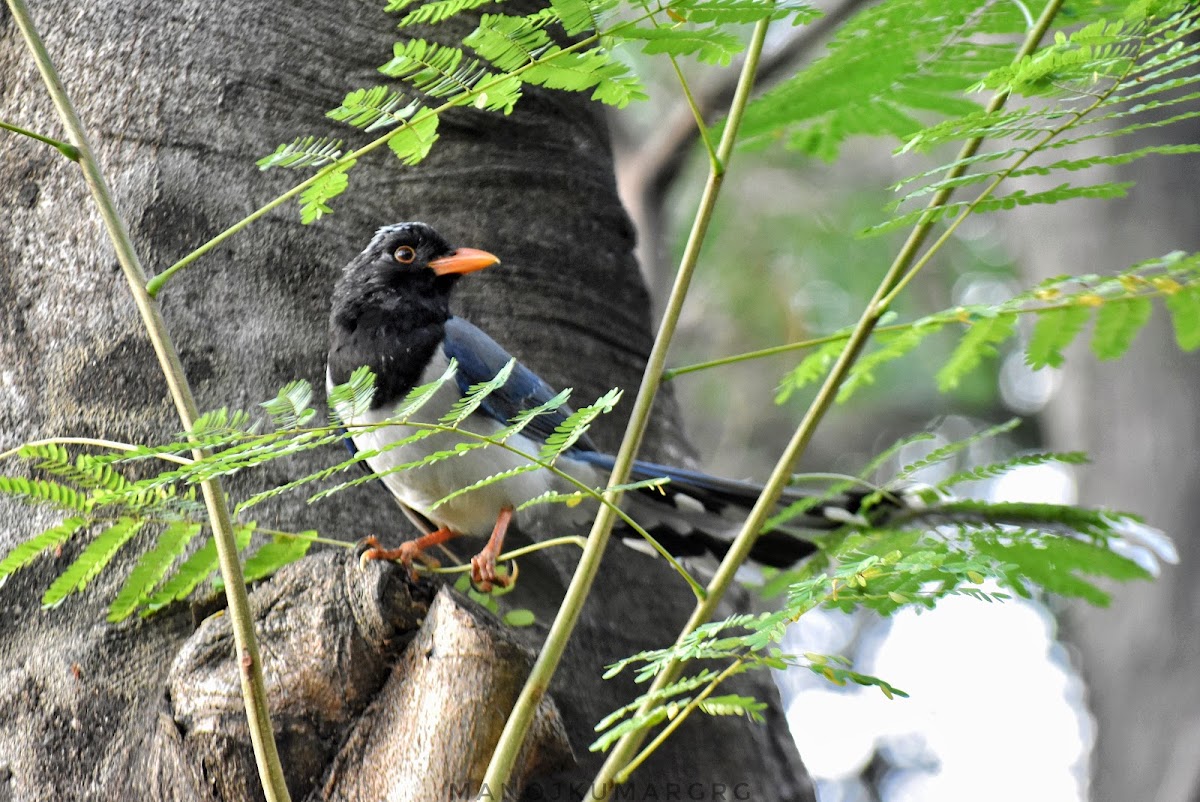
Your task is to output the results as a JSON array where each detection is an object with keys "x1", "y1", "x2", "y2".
[{"x1": 326, "y1": 222, "x2": 902, "y2": 588}]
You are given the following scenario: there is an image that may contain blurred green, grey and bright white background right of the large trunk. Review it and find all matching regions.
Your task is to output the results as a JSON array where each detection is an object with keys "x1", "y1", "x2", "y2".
[{"x1": 613, "y1": 0, "x2": 1200, "y2": 802}]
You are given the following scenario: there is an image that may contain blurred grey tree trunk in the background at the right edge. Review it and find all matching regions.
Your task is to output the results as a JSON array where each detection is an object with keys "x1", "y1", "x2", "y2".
[{"x1": 1020, "y1": 126, "x2": 1200, "y2": 802}]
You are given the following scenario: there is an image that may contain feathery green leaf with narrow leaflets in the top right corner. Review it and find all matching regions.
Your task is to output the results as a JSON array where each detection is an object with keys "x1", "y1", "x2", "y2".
[{"x1": 883, "y1": 2, "x2": 1200, "y2": 235}]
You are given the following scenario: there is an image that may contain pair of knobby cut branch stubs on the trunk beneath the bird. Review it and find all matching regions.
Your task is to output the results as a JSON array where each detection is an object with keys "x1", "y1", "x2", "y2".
[{"x1": 158, "y1": 552, "x2": 572, "y2": 802}]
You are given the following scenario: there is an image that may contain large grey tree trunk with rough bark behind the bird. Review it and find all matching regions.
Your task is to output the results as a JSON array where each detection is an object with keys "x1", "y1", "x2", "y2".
[{"x1": 0, "y1": 0, "x2": 812, "y2": 800}]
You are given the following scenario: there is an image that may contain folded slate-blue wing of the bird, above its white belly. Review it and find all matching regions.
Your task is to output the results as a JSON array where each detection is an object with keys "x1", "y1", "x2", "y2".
[{"x1": 442, "y1": 317, "x2": 595, "y2": 451}]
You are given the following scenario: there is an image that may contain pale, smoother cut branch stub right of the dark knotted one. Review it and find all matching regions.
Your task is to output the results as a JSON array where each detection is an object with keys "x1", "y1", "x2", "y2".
[{"x1": 320, "y1": 589, "x2": 575, "y2": 802}]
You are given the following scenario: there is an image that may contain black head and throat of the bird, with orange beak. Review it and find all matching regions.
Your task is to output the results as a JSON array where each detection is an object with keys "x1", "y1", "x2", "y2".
[{"x1": 329, "y1": 223, "x2": 499, "y2": 402}]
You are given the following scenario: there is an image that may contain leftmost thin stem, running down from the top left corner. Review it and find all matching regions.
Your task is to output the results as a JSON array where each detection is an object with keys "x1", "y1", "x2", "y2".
[{"x1": 7, "y1": 0, "x2": 290, "y2": 802}]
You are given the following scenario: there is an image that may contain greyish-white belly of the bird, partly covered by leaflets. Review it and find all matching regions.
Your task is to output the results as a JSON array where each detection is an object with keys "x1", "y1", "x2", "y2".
[{"x1": 328, "y1": 365, "x2": 601, "y2": 538}]
